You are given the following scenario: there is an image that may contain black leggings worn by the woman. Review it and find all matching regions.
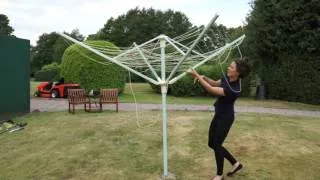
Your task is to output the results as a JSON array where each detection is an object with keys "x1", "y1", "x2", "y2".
[{"x1": 208, "y1": 114, "x2": 237, "y2": 175}]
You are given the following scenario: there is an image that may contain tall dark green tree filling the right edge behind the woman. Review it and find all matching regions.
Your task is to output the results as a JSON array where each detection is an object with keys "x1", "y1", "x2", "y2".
[{"x1": 246, "y1": 0, "x2": 320, "y2": 104}]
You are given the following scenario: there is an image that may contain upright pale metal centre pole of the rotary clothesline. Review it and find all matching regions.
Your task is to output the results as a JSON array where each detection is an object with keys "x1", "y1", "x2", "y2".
[{"x1": 160, "y1": 38, "x2": 168, "y2": 179}]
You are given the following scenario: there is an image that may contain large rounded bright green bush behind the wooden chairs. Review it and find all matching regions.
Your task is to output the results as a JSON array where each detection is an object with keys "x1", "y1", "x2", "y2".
[{"x1": 61, "y1": 41, "x2": 127, "y2": 92}]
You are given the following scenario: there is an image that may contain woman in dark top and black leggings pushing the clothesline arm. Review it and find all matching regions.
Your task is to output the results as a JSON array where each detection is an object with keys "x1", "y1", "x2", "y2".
[{"x1": 188, "y1": 58, "x2": 251, "y2": 180}]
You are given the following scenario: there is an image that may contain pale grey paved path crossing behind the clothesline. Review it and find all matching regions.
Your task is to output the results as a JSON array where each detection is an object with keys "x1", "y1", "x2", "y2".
[{"x1": 31, "y1": 98, "x2": 320, "y2": 118}]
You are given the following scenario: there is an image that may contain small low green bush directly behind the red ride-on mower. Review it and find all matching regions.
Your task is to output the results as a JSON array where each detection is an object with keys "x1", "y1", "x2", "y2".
[{"x1": 34, "y1": 63, "x2": 61, "y2": 81}]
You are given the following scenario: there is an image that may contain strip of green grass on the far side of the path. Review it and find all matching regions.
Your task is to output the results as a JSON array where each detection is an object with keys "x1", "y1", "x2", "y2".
[{"x1": 30, "y1": 82, "x2": 320, "y2": 110}]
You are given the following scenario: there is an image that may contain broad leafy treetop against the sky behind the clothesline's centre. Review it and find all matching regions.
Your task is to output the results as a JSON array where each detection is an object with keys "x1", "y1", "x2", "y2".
[{"x1": 88, "y1": 8, "x2": 192, "y2": 46}]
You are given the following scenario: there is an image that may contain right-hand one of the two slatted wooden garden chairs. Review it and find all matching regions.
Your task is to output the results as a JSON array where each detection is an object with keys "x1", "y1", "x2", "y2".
[{"x1": 99, "y1": 89, "x2": 119, "y2": 112}]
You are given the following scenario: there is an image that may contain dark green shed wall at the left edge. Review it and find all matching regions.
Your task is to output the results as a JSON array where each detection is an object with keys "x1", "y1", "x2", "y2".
[{"x1": 0, "y1": 36, "x2": 30, "y2": 120}]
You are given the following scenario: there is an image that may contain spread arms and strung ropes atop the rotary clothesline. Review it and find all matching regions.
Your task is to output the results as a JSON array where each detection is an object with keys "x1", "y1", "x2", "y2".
[{"x1": 60, "y1": 18, "x2": 244, "y2": 84}]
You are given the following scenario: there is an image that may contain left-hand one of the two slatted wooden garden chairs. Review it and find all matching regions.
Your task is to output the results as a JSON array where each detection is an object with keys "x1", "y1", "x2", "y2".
[{"x1": 68, "y1": 89, "x2": 90, "y2": 113}]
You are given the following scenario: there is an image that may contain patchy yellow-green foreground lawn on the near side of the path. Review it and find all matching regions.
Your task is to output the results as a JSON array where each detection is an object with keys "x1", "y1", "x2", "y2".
[{"x1": 0, "y1": 111, "x2": 320, "y2": 180}]
